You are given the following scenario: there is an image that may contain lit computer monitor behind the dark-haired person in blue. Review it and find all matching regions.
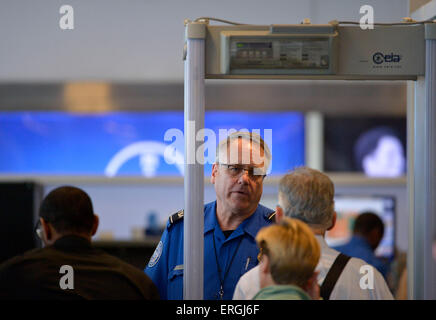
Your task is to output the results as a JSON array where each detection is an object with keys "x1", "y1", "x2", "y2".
[{"x1": 326, "y1": 195, "x2": 395, "y2": 259}]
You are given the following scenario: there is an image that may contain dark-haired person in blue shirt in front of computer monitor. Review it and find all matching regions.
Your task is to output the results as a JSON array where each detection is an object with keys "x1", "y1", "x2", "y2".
[{"x1": 335, "y1": 211, "x2": 388, "y2": 277}]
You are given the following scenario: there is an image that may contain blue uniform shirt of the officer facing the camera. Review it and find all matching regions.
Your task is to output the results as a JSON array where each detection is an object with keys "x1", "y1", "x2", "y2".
[{"x1": 145, "y1": 201, "x2": 274, "y2": 300}]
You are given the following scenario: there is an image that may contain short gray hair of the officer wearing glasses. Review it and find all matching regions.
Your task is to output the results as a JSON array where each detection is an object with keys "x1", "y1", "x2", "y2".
[{"x1": 215, "y1": 131, "x2": 271, "y2": 172}]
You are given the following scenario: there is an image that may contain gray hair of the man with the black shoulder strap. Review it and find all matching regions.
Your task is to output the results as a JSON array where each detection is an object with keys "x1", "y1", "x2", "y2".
[{"x1": 279, "y1": 167, "x2": 335, "y2": 229}]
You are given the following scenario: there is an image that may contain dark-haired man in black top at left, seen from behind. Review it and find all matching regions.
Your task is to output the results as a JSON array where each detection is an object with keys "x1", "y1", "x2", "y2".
[{"x1": 0, "y1": 186, "x2": 159, "y2": 300}]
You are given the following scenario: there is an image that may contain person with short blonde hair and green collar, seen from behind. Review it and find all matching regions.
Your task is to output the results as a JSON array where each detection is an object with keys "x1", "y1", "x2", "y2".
[{"x1": 254, "y1": 217, "x2": 321, "y2": 300}]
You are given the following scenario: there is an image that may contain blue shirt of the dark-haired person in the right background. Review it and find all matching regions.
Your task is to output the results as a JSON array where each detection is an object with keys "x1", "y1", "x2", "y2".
[{"x1": 334, "y1": 236, "x2": 388, "y2": 278}]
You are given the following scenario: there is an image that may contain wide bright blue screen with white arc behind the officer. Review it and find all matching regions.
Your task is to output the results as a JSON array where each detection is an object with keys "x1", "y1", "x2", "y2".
[{"x1": 0, "y1": 111, "x2": 304, "y2": 177}]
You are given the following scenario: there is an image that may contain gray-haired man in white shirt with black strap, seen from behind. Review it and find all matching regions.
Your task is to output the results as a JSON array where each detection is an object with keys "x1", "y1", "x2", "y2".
[{"x1": 233, "y1": 167, "x2": 393, "y2": 300}]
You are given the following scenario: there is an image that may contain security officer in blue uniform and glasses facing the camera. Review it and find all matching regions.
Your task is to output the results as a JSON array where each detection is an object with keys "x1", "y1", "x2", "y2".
[{"x1": 145, "y1": 132, "x2": 275, "y2": 300}]
